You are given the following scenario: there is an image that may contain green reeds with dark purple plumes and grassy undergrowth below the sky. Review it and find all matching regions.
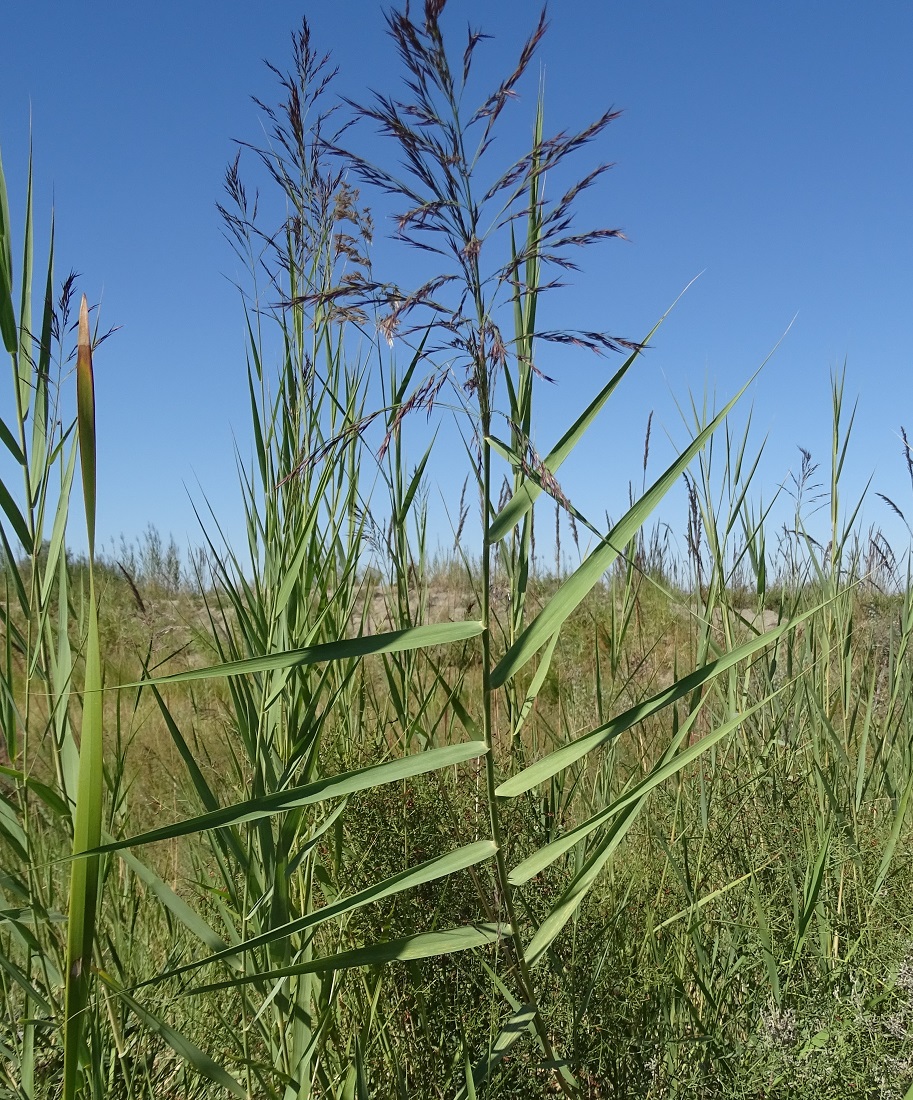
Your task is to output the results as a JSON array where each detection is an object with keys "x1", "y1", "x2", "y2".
[{"x1": 0, "y1": 0, "x2": 913, "y2": 1100}]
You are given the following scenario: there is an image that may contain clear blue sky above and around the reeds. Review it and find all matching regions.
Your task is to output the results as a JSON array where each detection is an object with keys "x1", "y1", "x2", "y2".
[{"x1": 0, "y1": 0, "x2": 913, "y2": 576}]
